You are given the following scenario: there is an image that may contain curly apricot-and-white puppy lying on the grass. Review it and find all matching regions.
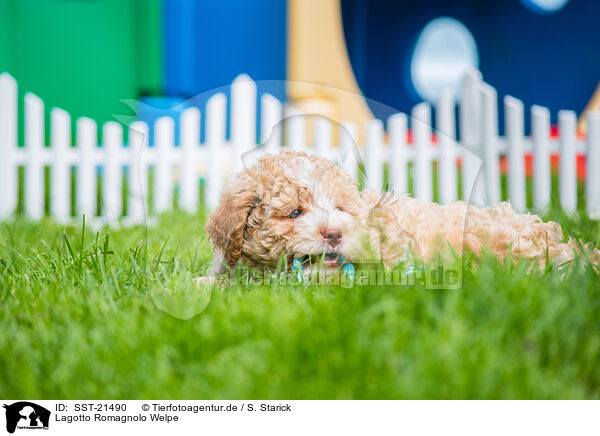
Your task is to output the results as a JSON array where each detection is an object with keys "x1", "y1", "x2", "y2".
[{"x1": 206, "y1": 151, "x2": 600, "y2": 275}]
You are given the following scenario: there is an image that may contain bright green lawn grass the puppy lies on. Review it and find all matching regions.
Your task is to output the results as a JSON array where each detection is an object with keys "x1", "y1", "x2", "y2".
[{"x1": 0, "y1": 208, "x2": 600, "y2": 399}]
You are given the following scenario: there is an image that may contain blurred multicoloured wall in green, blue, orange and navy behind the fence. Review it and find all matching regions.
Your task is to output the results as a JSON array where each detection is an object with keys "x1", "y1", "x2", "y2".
[{"x1": 0, "y1": 0, "x2": 600, "y2": 136}]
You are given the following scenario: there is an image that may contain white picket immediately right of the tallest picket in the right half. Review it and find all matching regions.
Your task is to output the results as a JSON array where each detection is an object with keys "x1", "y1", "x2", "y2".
[{"x1": 481, "y1": 84, "x2": 501, "y2": 204}]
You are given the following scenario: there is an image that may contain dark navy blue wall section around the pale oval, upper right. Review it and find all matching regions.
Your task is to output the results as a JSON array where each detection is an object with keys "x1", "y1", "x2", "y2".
[{"x1": 342, "y1": 0, "x2": 600, "y2": 129}]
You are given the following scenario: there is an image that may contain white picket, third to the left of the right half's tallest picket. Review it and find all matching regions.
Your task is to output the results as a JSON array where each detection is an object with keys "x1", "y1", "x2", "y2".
[{"x1": 388, "y1": 113, "x2": 408, "y2": 195}]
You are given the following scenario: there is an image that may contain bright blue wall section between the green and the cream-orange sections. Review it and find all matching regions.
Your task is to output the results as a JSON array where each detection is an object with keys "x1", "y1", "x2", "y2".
[{"x1": 165, "y1": 0, "x2": 286, "y2": 99}]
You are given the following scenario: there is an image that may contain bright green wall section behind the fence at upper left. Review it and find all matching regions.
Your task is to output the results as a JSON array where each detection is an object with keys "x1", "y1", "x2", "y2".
[{"x1": 0, "y1": 0, "x2": 162, "y2": 144}]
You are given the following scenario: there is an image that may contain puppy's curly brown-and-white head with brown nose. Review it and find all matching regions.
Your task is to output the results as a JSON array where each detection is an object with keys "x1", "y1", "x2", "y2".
[{"x1": 206, "y1": 151, "x2": 367, "y2": 268}]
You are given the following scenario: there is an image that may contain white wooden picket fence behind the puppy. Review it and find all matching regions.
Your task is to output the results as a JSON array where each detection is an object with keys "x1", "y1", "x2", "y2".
[{"x1": 0, "y1": 71, "x2": 600, "y2": 227}]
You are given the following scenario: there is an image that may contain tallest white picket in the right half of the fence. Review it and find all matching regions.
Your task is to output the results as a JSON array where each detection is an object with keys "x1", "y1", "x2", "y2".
[{"x1": 458, "y1": 69, "x2": 484, "y2": 205}]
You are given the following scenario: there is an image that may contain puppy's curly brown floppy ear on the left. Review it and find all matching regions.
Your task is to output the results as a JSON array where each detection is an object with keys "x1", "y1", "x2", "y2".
[{"x1": 206, "y1": 179, "x2": 261, "y2": 266}]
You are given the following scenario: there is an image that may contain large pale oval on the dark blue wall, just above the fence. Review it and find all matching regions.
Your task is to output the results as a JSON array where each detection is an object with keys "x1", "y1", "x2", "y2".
[{"x1": 410, "y1": 17, "x2": 479, "y2": 102}]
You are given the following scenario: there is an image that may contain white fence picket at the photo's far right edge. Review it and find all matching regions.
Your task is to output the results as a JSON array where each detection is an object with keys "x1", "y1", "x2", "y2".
[{"x1": 585, "y1": 111, "x2": 600, "y2": 219}]
